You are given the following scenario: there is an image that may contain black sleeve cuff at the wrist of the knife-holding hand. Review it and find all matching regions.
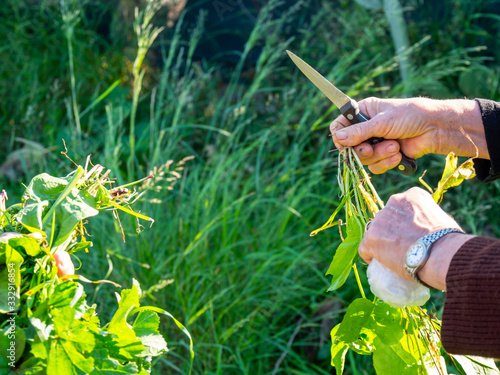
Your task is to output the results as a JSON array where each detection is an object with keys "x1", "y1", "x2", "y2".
[{"x1": 474, "y1": 99, "x2": 500, "y2": 182}]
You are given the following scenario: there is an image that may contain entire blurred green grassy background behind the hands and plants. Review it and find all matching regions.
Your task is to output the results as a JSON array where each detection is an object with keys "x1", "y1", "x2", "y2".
[{"x1": 0, "y1": 0, "x2": 500, "y2": 374}]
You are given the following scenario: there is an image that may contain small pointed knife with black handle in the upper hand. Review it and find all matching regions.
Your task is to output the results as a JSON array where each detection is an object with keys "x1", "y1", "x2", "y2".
[{"x1": 286, "y1": 50, "x2": 417, "y2": 176}]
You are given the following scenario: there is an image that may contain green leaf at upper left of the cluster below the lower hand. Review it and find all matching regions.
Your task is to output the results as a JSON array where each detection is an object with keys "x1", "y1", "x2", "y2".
[{"x1": 337, "y1": 298, "x2": 375, "y2": 343}]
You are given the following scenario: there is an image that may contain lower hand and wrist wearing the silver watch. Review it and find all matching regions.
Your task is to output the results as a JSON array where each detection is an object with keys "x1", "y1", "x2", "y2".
[{"x1": 359, "y1": 187, "x2": 471, "y2": 290}]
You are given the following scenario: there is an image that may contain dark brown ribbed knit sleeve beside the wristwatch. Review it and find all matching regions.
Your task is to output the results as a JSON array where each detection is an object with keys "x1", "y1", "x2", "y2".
[{"x1": 441, "y1": 237, "x2": 500, "y2": 358}]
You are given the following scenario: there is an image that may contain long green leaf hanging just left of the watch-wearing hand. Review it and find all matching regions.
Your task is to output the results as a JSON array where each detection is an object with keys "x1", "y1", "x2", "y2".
[{"x1": 326, "y1": 215, "x2": 363, "y2": 291}]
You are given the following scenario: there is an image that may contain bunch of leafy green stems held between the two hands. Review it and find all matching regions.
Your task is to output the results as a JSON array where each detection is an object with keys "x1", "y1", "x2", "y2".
[{"x1": 311, "y1": 147, "x2": 497, "y2": 375}]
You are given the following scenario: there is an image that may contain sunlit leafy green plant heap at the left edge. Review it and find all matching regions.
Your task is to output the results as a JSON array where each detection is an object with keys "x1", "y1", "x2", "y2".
[{"x1": 0, "y1": 159, "x2": 194, "y2": 375}]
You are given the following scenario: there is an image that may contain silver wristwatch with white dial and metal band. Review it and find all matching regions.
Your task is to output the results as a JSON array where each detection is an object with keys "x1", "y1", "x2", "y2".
[{"x1": 405, "y1": 228, "x2": 465, "y2": 288}]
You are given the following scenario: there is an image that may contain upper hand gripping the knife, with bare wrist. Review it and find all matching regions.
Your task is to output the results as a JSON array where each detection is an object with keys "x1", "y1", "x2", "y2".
[{"x1": 330, "y1": 98, "x2": 489, "y2": 174}]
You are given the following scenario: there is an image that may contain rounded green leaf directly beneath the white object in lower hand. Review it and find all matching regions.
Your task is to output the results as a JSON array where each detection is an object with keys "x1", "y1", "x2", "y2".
[{"x1": 370, "y1": 303, "x2": 405, "y2": 345}]
